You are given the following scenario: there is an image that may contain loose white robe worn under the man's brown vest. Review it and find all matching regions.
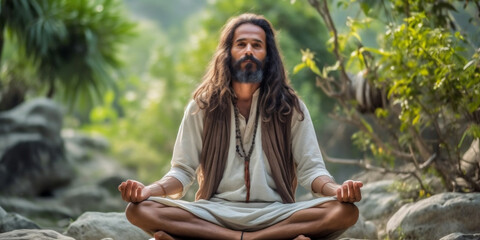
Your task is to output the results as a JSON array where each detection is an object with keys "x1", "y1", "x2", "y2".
[{"x1": 149, "y1": 90, "x2": 336, "y2": 231}]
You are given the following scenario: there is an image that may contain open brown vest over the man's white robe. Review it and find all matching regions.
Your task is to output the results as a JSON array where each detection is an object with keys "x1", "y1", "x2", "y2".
[{"x1": 195, "y1": 100, "x2": 297, "y2": 203}]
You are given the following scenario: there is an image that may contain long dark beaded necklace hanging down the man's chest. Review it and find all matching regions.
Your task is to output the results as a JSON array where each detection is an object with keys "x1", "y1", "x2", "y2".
[{"x1": 233, "y1": 100, "x2": 260, "y2": 203}]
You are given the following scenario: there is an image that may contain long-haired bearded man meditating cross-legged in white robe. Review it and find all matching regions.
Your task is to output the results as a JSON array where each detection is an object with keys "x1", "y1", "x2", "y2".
[{"x1": 119, "y1": 14, "x2": 363, "y2": 239}]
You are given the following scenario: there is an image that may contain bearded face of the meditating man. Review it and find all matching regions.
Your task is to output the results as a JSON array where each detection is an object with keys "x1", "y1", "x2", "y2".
[{"x1": 230, "y1": 23, "x2": 267, "y2": 83}]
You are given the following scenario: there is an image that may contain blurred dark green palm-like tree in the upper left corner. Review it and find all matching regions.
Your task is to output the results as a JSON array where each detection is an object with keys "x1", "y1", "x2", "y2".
[{"x1": 0, "y1": 0, "x2": 133, "y2": 110}]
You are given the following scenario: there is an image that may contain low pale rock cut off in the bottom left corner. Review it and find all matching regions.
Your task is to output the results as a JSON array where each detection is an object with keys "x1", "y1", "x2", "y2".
[{"x1": 0, "y1": 229, "x2": 75, "y2": 240}]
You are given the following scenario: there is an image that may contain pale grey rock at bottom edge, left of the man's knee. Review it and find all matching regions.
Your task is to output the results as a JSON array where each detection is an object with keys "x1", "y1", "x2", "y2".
[{"x1": 64, "y1": 212, "x2": 151, "y2": 240}]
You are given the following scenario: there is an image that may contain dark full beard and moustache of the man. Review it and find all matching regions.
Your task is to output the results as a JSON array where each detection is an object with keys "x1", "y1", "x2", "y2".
[{"x1": 233, "y1": 55, "x2": 263, "y2": 83}]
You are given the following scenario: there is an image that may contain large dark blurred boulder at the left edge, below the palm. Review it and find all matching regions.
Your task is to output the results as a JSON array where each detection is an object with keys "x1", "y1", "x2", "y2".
[{"x1": 0, "y1": 99, "x2": 73, "y2": 196}]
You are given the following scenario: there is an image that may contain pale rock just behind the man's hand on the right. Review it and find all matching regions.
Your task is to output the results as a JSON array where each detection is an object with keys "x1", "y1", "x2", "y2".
[{"x1": 355, "y1": 180, "x2": 401, "y2": 220}]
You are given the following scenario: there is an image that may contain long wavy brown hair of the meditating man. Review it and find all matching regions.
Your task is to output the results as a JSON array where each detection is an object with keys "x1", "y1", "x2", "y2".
[{"x1": 193, "y1": 13, "x2": 304, "y2": 122}]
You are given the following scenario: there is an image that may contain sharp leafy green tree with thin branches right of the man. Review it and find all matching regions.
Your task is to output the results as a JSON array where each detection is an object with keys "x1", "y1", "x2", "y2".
[{"x1": 297, "y1": 0, "x2": 480, "y2": 192}]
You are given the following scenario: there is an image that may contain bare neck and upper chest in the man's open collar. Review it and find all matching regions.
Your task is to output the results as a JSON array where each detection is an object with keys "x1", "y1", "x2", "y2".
[{"x1": 232, "y1": 81, "x2": 260, "y2": 121}]
